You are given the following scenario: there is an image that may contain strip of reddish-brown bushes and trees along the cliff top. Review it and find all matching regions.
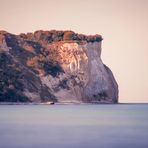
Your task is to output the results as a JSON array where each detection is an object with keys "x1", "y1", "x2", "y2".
[{"x1": 0, "y1": 30, "x2": 103, "y2": 43}]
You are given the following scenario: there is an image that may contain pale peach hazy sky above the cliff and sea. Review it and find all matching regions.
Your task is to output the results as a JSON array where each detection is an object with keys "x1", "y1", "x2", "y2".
[{"x1": 0, "y1": 0, "x2": 148, "y2": 102}]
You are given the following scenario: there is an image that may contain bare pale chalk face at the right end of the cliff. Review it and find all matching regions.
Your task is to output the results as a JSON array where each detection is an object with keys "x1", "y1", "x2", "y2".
[{"x1": 41, "y1": 42, "x2": 118, "y2": 103}]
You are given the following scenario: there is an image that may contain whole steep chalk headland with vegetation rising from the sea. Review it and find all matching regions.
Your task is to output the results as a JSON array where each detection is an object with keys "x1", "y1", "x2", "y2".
[{"x1": 0, "y1": 30, "x2": 118, "y2": 103}]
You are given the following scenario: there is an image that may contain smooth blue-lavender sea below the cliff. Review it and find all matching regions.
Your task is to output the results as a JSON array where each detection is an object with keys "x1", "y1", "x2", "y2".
[{"x1": 0, "y1": 104, "x2": 148, "y2": 148}]
